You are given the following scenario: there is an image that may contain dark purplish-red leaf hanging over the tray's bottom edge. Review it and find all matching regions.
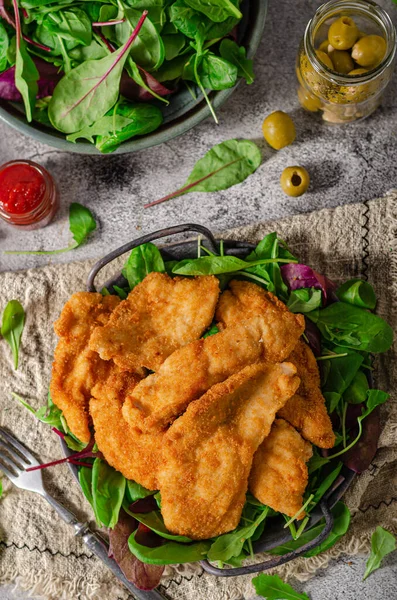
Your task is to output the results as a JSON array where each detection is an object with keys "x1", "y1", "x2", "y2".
[{"x1": 109, "y1": 509, "x2": 164, "y2": 591}]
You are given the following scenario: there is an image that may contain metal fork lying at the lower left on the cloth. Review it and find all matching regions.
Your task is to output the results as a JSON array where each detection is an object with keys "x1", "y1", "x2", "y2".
[{"x1": 0, "y1": 427, "x2": 165, "y2": 600}]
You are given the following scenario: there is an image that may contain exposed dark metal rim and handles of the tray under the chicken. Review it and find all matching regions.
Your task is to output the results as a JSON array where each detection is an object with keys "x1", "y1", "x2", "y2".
[{"x1": 61, "y1": 223, "x2": 356, "y2": 577}]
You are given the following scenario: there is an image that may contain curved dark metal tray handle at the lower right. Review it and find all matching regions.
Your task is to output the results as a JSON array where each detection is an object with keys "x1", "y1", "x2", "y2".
[{"x1": 200, "y1": 501, "x2": 334, "y2": 577}]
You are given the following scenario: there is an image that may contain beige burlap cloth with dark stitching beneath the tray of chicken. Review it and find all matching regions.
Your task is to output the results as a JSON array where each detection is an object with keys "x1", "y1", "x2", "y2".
[{"x1": 0, "y1": 191, "x2": 397, "y2": 600}]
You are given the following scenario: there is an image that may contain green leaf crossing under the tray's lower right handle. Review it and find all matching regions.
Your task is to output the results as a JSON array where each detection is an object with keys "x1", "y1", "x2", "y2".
[{"x1": 269, "y1": 502, "x2": 351, "y2": 558}]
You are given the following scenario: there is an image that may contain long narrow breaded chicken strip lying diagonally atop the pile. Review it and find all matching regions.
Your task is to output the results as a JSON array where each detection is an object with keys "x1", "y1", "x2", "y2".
[{"x1": 123, "y1": 282, "x2": 304, "y2": 431}]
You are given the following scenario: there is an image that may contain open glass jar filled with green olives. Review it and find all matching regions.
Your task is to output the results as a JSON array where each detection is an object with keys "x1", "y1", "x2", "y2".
[{"x1": 296, "y1": 0, "x2": 396, "y2": 123}]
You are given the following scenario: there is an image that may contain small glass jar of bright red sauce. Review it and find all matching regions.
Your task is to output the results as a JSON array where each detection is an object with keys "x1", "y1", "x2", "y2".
[{"x1": 0, "y1": 160, "x2": 59, "y2": 230}]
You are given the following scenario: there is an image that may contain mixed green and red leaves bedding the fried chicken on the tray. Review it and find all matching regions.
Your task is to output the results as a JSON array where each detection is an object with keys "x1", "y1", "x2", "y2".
[{"x1": 24, "y1": 224, "x2": 393, "y2": 589}]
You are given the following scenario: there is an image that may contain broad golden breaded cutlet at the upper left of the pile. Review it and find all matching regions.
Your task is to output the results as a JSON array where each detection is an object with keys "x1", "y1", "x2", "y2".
[{"x1": 90, "y1": 273, "x2": 219, "y2": 371}]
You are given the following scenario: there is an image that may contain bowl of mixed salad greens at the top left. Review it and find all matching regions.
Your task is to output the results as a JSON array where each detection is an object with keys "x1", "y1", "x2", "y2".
[{"x1": 0, "y1": 0, "x2": 267, "y2": 154}]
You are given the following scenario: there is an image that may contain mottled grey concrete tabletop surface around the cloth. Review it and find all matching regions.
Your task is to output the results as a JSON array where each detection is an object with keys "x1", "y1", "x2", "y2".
[{"x1": 0, "y1": 0, "x2": 397, "y2": 600}]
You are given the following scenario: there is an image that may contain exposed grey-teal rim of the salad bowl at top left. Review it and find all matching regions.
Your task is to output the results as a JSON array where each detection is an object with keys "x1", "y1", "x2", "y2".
[{"x1": 0, "y1": 0, "x2": 267, "y2": 156}]
